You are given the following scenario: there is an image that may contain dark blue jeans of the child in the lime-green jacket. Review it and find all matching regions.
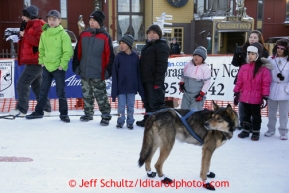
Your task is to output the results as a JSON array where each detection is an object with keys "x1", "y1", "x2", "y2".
[{"x1": 35, "y1": 67, "x2": 68, "y2": 115}]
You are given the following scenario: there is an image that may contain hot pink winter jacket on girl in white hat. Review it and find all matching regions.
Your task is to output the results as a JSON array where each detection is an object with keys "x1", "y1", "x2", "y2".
[{"x1": 234, "y1": 58, "x2": 272, "y2": 104}]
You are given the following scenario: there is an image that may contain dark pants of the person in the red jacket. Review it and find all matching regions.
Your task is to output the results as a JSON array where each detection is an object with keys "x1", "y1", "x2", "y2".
[{"x1": 16, "y1": 64, "x2": 51, "y2": 114}]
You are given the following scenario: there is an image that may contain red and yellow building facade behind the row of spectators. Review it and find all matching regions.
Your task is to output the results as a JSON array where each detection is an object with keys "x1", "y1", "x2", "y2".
[{"x1": 0, "y1": 0, "x2": 289, "y2": 57}]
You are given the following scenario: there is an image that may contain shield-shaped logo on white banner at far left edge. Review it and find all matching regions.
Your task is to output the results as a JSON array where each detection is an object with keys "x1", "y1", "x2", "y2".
[{"x1": 0, "y1": 62, "x2": 13, "y2": 92}]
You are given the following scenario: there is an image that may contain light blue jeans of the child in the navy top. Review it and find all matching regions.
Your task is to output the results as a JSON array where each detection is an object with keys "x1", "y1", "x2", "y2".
[{"x1": 117, "y1": 93, "x2": 135, "y2": 125}]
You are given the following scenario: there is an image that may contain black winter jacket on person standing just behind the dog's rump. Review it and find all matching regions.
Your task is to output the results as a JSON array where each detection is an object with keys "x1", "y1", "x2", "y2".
[{"x1": 140, "y1": 39, "x2": 170, "y2": 87}]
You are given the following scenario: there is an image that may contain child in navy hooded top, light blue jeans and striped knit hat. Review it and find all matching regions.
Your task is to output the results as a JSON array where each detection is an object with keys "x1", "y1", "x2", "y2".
[{"x1": 111, "y1": 34, "x2": 144, "y2": 129}]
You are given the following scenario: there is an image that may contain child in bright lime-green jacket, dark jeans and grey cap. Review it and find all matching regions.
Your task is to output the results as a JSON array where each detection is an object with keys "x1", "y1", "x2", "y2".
[{"x1": 26, "y1": 10, "x2": 73, "y2": 123}]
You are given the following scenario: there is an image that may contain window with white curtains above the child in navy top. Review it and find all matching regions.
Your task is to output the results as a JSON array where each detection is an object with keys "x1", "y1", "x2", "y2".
[{"x1": 117, "y1": 0, "x2": 145, "y2": 41}]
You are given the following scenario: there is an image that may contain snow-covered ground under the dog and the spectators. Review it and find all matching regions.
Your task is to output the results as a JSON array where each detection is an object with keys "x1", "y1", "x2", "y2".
[{"x1": 0, "y1": 110, "x2": 289, "y2": 193}]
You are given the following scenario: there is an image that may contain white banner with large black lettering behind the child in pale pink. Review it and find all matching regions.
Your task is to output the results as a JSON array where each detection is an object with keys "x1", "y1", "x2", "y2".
[{"x1": 165, "y1": 56, "x2": 238, "y2": 101}]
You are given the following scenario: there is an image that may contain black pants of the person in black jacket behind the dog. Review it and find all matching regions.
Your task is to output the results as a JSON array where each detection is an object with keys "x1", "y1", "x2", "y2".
[{"x1": 142, "y1": 83, "x2": 165, "y2": 112}]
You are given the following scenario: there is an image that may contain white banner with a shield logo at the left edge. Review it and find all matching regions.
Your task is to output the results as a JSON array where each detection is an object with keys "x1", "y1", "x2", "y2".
[{"x1": 0, "y1": 59, "x2": 15, "y2": 99}]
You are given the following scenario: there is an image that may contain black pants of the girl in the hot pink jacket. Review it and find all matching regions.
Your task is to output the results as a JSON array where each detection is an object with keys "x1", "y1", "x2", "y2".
[{"x1": 243, "y1": 103, "x2": 262, "y2": 133}]
